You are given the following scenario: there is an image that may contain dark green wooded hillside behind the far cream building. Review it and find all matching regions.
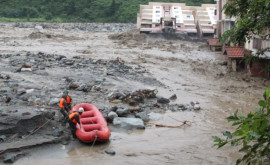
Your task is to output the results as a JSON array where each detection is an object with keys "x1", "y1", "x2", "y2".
[{"x1": 0, "y1": 0, "x2": 215, "y2": 23}]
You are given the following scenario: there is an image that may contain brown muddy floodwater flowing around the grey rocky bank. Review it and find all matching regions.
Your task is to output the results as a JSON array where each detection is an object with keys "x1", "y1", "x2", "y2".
[{"x1": 0, "y1": 24, "x2": 270, "y2": 165}]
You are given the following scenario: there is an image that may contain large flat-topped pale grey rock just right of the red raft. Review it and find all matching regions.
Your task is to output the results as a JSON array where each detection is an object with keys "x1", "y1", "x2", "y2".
[{"x1": 113, "y1": 117, "x2": 145, "y2": 130}]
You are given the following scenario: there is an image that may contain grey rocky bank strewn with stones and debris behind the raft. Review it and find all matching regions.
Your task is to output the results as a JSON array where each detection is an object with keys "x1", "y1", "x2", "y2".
[{"x1": 0, "y1": 52, "x2": 200, "y2": 162}]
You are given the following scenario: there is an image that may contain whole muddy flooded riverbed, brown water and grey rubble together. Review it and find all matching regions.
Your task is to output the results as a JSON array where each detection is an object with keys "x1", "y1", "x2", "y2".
[{"x1": 0, "y1": 23, "x2": 269, "y2": 165}]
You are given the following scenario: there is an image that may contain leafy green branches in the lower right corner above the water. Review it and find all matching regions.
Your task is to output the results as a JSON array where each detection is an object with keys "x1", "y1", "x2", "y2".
[{"x1": 213, "y1": 87, "x2": 270, "y2": 164}]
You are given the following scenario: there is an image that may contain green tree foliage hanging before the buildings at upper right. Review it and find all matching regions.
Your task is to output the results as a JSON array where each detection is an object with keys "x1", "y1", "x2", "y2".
[{"x1": 222, "y1": 0, "x2": 270, "y2": 50}]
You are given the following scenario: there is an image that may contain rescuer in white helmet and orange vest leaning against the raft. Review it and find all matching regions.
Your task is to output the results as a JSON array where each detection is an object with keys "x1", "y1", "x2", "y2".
[{"x1": 68, "y1": 107, "x2": 84, "y2": 138}]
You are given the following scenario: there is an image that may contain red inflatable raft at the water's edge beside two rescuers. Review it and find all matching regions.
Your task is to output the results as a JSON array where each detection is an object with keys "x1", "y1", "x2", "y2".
[{"x1": 71, "y1": 103, "x2": 111, "y2": 143}]
